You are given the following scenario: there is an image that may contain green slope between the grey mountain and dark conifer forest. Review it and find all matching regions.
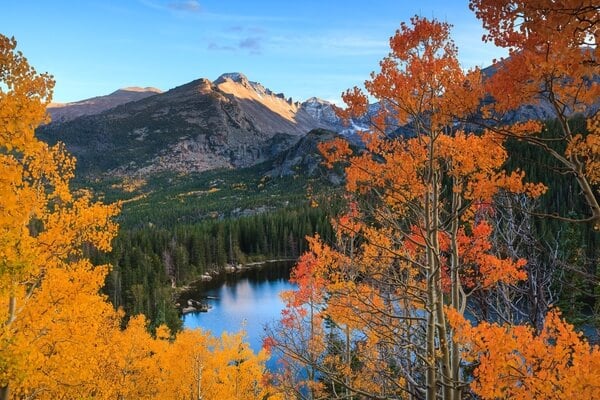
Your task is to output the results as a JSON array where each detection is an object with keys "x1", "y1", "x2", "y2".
[{"x1": 77, "y1": 159, "x2": 336, "y2": 228}]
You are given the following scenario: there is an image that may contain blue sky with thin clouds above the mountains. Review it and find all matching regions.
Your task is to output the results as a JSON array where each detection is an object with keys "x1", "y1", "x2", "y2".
[{"x1": 0, "y1": 0, "x2": 504, "y2": 102}]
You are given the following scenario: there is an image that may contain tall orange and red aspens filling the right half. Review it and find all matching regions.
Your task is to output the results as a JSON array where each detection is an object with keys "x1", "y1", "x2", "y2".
[{"x1": 269, "y1": 5, "x2": 600, "y2": 399}]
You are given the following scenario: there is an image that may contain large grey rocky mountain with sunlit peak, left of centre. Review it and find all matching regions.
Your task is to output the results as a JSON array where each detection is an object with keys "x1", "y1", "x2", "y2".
[{"x1": 39, "y1": 73, "x2": 335, "y2": 176}]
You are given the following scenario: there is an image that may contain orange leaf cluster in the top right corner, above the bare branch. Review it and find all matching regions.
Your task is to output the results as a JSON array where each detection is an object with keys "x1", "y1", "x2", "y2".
[{"x1": 470, "y1": 0, "x2": 600, "y2": 118}]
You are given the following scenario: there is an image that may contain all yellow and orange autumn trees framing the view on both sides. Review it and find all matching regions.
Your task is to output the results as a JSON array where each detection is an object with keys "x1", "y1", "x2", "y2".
[{"x1": 0, "y1": 0, "x2": 600, "y2": 400}]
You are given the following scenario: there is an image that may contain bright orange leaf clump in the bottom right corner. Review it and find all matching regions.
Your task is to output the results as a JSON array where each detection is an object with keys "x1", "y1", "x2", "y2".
[{"x1": 447, "y1": 309, "x2": 600, "y2": 400}]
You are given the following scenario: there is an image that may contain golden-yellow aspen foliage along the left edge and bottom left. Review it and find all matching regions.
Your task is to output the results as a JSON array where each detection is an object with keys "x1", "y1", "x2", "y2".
[{"x1": 0, "y1": 35, "x2": 274, "y2": 399}]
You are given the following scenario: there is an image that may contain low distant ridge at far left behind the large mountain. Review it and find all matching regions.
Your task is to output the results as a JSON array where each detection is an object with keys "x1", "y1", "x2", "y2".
[{"x1": 48, "y1": 86, "x2": 162, "y2": 122}]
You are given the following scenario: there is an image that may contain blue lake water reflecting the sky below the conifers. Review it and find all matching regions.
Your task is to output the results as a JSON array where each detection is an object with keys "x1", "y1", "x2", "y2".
[{"x1": 180, "y1": 262, "x2": 295, "y2": 351}]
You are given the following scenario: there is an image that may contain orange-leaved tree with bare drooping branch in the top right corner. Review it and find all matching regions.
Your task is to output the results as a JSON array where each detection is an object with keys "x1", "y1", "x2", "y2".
[{"x1": 470, "y1": 0, "x2": 600, "y2": 230}]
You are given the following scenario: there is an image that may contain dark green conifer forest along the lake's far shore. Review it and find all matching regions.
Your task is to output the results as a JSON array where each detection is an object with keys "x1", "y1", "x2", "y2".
[{"x1": 98, "y1": 205, "x2": 332, "y2": 332}]
